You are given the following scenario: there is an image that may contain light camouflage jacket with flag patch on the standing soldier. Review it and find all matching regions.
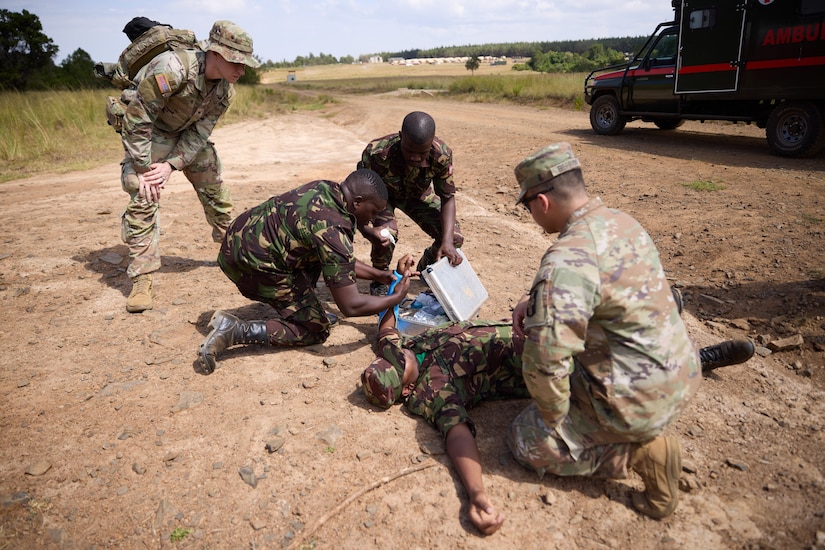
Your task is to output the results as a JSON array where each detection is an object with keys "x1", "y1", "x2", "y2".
[{"x1": 122, "y1": 50, "x2": 235, "y2": 173}]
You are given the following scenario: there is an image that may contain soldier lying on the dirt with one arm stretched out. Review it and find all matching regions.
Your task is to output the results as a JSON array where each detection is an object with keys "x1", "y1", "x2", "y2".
[{"x1": 361, "y1": 256, "x2": 529, "y2": 535}]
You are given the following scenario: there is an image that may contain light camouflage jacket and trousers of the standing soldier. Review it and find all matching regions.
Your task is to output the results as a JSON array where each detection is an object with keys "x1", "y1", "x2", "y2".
[{"x1": 121, "y1": 50, "x2": 235, "y2": 277}]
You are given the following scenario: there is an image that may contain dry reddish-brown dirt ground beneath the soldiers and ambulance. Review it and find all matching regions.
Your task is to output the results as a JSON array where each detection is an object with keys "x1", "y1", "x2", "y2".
[{"x1": 0, "y1": 92, "x2": 825, "y2": 548}]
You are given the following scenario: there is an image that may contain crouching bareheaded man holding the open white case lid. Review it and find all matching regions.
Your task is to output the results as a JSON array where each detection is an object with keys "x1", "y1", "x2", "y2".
[{"x1": 358, "y1": 111, "x2": 464, "y2": 294}]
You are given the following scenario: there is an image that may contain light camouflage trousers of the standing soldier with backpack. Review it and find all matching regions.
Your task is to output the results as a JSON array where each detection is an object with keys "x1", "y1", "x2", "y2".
[{"x1": 120, "y1": 131, "x2": 232, "y2": 277}]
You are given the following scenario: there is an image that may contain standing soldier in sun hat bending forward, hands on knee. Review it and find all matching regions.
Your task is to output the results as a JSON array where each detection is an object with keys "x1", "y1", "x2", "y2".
[{"x1": 121, "y1": 21, "x2": 260, "y2": 312}]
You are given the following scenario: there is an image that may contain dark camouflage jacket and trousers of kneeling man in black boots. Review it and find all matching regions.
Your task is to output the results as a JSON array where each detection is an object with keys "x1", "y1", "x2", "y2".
[{"x1": 218, "y1": 181, "x2": 356, "y2": 346}]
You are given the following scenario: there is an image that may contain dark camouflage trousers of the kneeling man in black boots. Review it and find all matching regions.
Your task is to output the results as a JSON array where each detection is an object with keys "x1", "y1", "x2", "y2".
[{"x1": 218, "y1": 213, "x2": 330, "y2": 347}]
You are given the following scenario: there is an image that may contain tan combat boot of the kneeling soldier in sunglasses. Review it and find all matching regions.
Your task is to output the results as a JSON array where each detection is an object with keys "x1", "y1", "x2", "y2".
[{"x1": 630, "y1": 436, "x2": 682, "y2": 519}]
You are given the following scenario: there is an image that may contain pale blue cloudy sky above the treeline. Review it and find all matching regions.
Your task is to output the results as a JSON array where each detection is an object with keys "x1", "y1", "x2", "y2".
[{"x1": 6, "y1": 0, "x2": 673, "y2": 64}]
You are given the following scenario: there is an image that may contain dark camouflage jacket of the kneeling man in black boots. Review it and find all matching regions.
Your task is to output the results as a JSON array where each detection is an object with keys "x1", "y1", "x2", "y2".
[{"x1": 226, "y1": 180, "x2": 356, "y2": 287}]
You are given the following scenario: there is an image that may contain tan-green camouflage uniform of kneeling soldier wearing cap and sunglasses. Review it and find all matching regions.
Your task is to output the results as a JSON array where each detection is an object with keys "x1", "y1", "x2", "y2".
[{"x1": 508, "y1": 198, "x2": 702, "y2": 478}]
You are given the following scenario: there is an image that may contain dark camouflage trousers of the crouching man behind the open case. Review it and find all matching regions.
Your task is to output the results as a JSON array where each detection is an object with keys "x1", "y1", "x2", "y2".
[{"x1": 370, "y1": 191, "x2": 464, "y2": 269}]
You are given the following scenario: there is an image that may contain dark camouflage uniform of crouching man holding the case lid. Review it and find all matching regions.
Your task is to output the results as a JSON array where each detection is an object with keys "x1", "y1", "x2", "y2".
[{"x1": 358, "y1": 133, "x2": 464, "y2": 269}]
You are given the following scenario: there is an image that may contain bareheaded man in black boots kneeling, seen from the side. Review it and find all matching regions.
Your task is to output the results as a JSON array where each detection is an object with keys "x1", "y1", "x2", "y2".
[{"x1": 198, "y1": 170, "x2": 409, "y2": 374}]
